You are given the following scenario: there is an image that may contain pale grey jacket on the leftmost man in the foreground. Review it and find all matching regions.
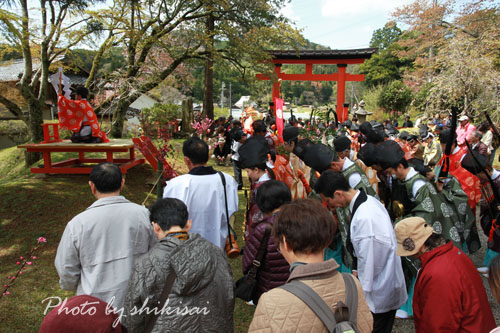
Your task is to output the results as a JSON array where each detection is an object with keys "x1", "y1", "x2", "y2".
[{"x1": 55, "y1": 196, "x2": 158, "y2": 309}]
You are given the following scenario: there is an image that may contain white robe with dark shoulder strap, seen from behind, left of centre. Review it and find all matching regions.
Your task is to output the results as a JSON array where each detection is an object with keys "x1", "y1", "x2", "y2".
[{"x1": 163, "y1": 172, "x2": 238, "y2": 249}]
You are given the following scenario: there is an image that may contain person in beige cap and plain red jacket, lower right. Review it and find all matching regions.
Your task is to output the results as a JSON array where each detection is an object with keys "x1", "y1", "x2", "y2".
[{"x1": 394, "y1": 217, "x2": 496, "y2": 333}]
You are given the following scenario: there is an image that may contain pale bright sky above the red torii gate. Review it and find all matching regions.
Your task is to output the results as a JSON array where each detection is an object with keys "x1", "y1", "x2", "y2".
[{"x1": 282, "y1": 0, "x2": 411, "y2": 49}]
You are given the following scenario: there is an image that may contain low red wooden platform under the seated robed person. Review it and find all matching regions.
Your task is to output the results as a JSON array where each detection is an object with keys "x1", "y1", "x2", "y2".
[{"x1": 17, "y1": 139, "x2": 144, "y2": 174}]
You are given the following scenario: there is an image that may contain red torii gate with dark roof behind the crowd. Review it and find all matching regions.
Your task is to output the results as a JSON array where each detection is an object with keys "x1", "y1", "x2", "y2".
[{"x1": 257, "y1": 48, "x2": 378, "y2": 122}]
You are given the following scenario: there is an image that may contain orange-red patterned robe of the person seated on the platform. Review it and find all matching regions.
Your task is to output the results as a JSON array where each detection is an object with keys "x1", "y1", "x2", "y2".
[{"x1": 57, "y1": 95, "x2": 109, "y2": 142}]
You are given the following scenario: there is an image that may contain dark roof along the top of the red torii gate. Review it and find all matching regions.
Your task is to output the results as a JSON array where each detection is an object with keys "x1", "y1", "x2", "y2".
[{"x1": 267, "y1": 48, "x2": 378, "y2": 60}]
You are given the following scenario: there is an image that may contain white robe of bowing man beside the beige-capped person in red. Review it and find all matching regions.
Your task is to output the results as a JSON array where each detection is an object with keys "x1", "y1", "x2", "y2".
[{"x1": 349, "y1": 191, "x2": 408, "y2": 313}]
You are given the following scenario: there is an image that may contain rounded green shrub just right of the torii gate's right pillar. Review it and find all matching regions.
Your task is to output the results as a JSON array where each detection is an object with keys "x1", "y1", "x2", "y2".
[{"x1": 378, "y1": 81, "x2": 413, "y2": 113}]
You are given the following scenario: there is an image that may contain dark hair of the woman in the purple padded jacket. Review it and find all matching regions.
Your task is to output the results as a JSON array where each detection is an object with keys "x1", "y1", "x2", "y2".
[{"x1": 255, "y1": 180, "x2": 292, "y2": 214}]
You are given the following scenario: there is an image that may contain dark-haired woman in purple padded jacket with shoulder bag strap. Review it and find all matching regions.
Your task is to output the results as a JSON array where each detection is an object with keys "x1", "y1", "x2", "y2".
[{"x1": 243, "y1": 180, "x2": 292, "y2": 304}]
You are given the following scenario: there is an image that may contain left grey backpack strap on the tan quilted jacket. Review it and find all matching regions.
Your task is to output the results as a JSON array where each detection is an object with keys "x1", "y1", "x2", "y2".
[{"x1": 280, "y1": 280, "x2": 337, "y2": 333}]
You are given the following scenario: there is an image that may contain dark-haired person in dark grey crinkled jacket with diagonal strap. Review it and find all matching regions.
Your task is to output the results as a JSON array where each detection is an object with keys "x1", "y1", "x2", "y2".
[{"x1": 122, "y1": 198, "x2": 234, "y2": 332}]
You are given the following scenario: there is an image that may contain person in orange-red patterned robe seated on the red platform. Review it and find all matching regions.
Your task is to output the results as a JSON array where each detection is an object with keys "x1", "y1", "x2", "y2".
[{"x1": 57, "y1": 87, "x2": 109, "y2": 143}]
